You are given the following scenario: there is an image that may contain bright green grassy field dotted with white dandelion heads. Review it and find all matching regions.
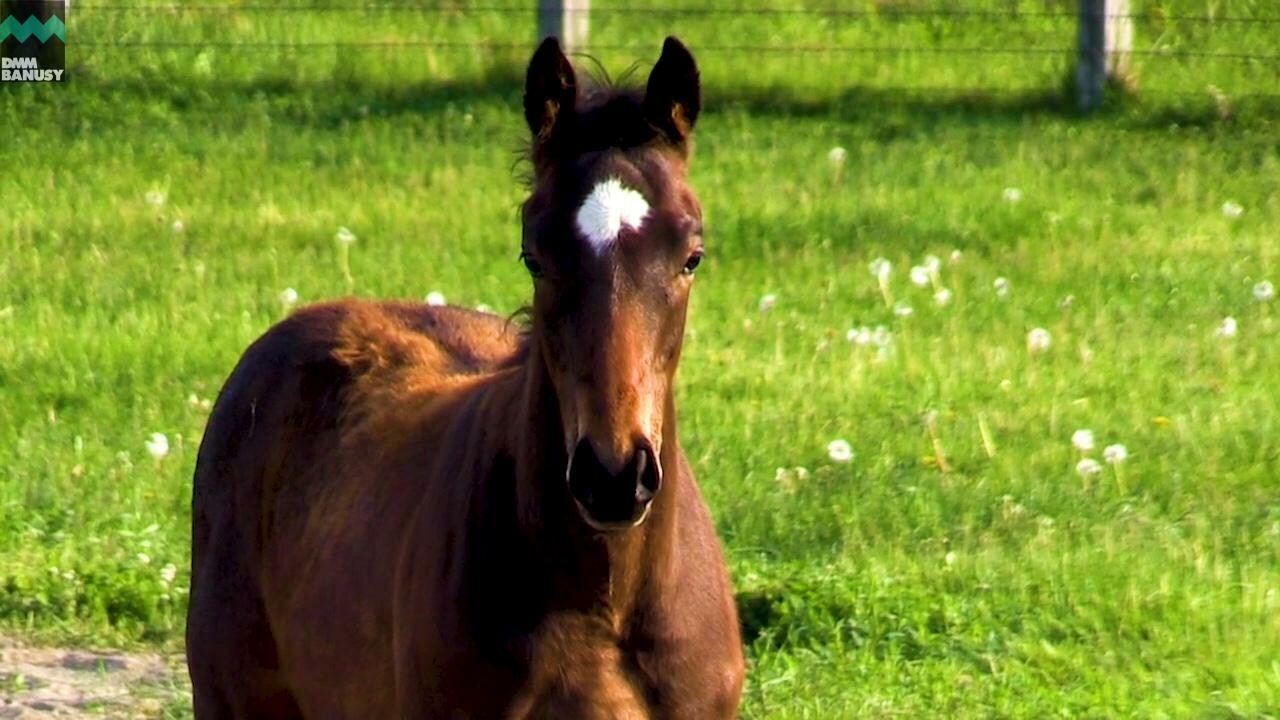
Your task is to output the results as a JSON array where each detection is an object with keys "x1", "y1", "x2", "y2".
[{"x1": 0, "y1": 0, "x2": 1280, "y2": 719}]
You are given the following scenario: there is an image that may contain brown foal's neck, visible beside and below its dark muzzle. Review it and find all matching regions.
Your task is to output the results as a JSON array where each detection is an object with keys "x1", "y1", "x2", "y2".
[{"x1": 508, "y1": 351, "x2": 684, "y2": 611}]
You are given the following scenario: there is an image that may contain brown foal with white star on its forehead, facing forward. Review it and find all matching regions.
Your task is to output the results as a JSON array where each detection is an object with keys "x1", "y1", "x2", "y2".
[{"x1": 187, "y1": 38, "x2": 744, "y2": 720}]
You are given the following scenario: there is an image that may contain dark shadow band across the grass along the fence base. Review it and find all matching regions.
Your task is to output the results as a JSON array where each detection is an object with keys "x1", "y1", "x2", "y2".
[{"x1": 0, "y1": 65, "x2": 1280, "y2": 138}]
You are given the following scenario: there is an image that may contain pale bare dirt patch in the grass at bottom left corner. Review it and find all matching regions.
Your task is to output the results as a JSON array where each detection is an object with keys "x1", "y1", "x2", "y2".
[{"x1": 0, "y1": 637, "x2": 189, "y2": 720}]
